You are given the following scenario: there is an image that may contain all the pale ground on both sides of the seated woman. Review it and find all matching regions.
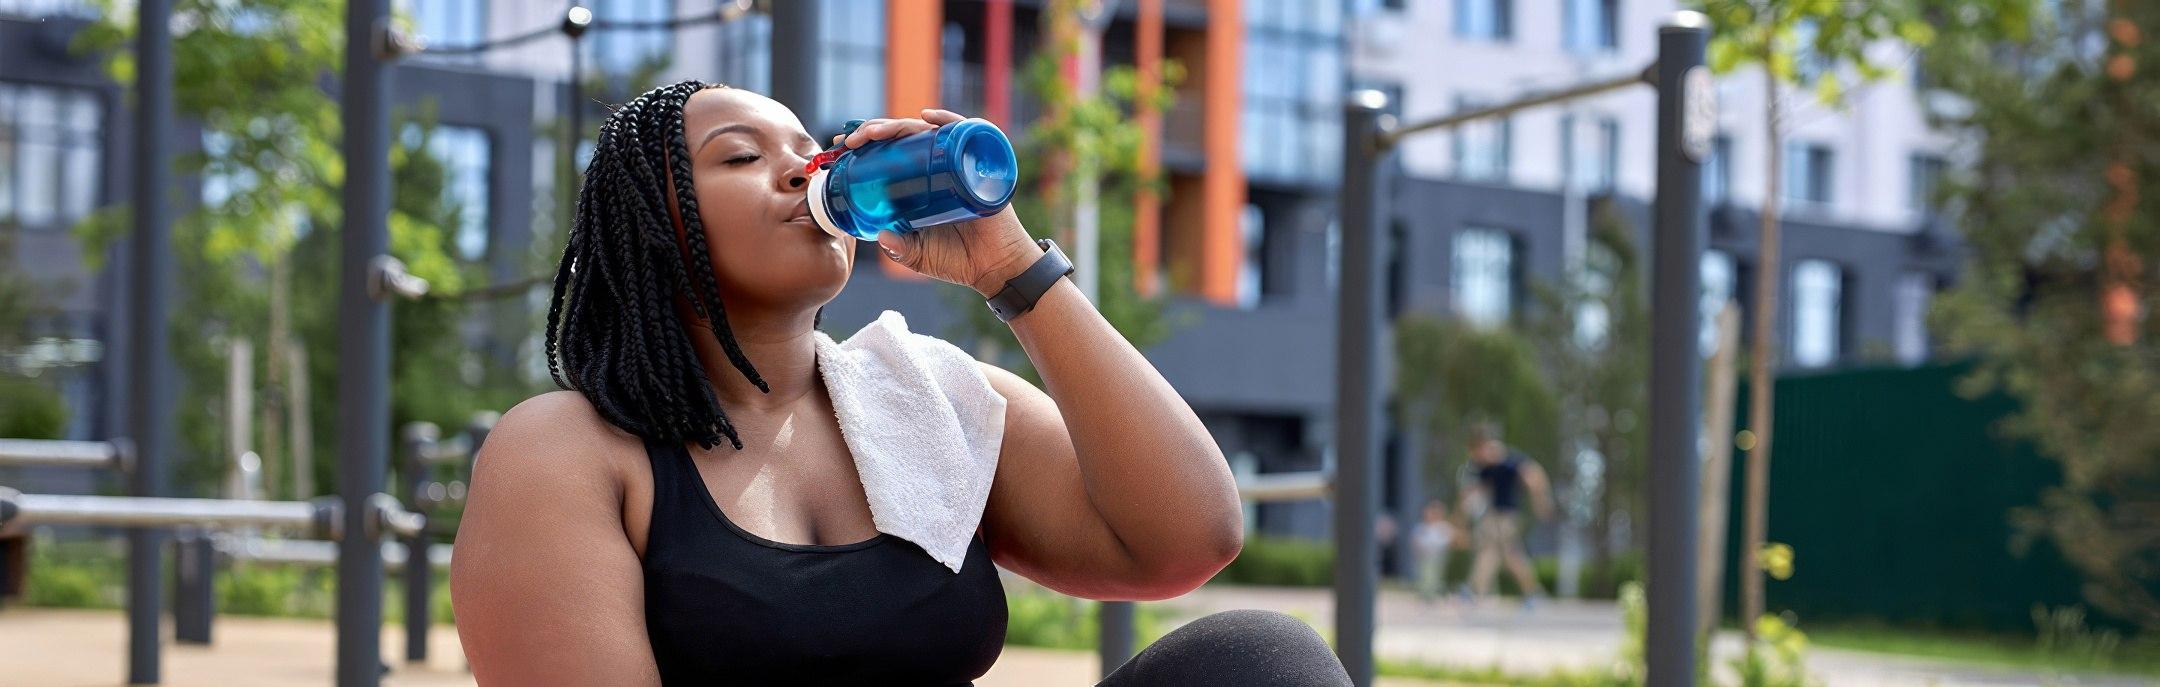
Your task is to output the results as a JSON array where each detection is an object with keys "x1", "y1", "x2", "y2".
[{"x1": 0, "y1": 588, "x2": 2154, "y2": 687}]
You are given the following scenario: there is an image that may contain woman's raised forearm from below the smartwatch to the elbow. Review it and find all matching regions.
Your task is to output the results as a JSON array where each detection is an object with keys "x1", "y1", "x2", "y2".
[{"x1": 1011, "y1": 279, "x2": 1244, "y2": 575}]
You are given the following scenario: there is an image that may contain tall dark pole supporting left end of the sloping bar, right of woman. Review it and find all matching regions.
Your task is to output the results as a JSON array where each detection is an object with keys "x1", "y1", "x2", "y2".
[{"x1": 1335, "y1": 91, "x2": 1387, "y2": 687}]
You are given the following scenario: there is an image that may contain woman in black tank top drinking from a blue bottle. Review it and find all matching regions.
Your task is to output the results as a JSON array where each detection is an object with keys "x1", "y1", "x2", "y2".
[{"x1": 451, "y1": 82, "x2": 1350, "y2": 685}]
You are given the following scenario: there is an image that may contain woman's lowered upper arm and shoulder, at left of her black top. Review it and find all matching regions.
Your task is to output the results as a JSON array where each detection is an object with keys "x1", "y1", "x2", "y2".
[{"x1": 449, "y1": 391, "x2": 659, "y2": 685}]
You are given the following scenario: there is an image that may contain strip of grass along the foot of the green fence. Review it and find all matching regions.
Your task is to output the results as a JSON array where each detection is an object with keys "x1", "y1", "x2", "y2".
[{"x1": 1808, "y1": 624, "x2": 2160, "y2": 678}]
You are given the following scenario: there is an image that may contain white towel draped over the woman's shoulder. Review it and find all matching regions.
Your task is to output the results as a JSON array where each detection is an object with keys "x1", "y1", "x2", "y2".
[{"x1": 816, "y1": 311, "x2": 1004, "y2": 573}]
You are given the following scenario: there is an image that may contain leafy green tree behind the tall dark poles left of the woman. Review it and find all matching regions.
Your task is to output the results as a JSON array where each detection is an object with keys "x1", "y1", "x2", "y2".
[{"x1": 78, "y1": 0, "x2": 527, "y2": 495}]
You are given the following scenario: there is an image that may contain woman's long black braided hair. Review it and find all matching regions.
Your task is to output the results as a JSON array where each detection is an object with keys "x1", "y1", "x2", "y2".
[{"x1": 546, "y1": 80, "x2": 771, "y2": 449}]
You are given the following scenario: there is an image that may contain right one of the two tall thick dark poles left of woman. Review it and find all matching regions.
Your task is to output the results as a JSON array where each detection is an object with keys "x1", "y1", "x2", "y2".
[{"x1": 337, "y1": 0, "x2": 391, "y2": 687}]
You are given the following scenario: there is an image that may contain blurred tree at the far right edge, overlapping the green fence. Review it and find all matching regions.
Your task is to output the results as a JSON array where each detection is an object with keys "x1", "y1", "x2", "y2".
[{"x1": 1927, "y1": 0, "x2": 2160, "y2": 631}]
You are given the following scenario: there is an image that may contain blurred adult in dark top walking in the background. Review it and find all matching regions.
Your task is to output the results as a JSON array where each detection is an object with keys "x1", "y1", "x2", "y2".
[{"x1": 1462, "y1": 421, "x2": 1553, "y2": 605}]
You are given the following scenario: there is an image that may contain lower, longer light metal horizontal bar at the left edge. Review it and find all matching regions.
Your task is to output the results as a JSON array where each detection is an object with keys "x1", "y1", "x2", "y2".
[{"x1": 0, "y1": 490, "x2": 337, "y2": 538}]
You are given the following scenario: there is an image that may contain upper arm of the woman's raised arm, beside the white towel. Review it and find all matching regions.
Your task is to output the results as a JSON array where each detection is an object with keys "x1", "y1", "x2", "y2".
[{"x1": 978, "y1": 363, "x2": 1132, "y2": 598}]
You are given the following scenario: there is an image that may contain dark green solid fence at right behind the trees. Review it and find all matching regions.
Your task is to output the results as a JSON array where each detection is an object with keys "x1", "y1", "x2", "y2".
[{"x1": 1726, "y1": 365, "x2": 2080, "y2": 631}]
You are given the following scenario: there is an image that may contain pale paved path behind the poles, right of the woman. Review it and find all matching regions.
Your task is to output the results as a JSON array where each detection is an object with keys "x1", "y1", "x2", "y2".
[{"x1": 1158, "y1": 585, "x2": 2151, "y2": 687}]
